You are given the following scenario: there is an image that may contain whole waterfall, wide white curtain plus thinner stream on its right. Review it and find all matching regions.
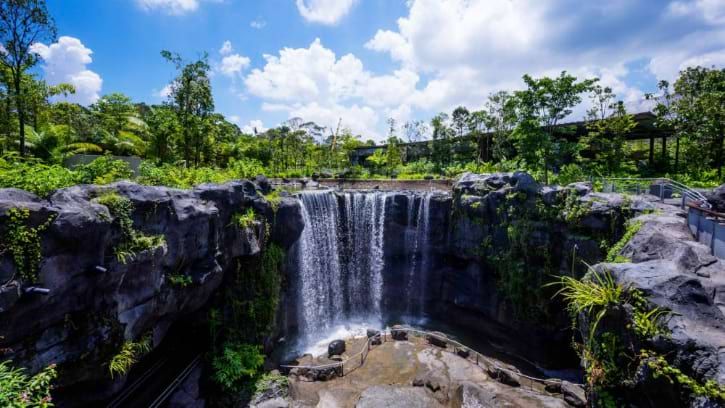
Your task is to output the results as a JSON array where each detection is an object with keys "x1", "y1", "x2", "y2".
[{"x1": 294, "y1": 190, "x2": 434, "y2": 354}]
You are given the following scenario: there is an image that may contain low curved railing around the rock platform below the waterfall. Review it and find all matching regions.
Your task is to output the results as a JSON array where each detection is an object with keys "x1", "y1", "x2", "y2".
[{"x1": 280, "y1": 327, "x2": 583, "y2": 388}]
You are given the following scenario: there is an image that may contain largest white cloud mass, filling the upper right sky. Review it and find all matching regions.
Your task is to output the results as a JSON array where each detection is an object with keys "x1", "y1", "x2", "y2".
[{"x1": 365, "y1": 0, "x2": 725, "y2": 119}]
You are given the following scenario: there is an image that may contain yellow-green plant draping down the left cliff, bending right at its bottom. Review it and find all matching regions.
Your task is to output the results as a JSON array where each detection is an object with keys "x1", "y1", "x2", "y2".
[{"x1": 96, "y1": 192, "x2": 165, "y2": 263}]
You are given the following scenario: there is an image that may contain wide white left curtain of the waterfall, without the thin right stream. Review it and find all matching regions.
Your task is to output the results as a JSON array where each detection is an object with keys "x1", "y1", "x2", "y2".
[{"x1": 297, "y1": 191, "x2": 388, "y2": 340}]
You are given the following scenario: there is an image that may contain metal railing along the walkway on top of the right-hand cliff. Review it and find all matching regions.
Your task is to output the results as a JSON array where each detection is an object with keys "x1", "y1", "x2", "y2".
[{"x1": 601, "y1": 178, "x2": 710, "y2": 209}]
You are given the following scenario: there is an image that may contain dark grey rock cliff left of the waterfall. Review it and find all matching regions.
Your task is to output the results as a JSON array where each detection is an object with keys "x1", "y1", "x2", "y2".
[{"x1": 0, "y1": 181, "x2": 303, "y2": 402}]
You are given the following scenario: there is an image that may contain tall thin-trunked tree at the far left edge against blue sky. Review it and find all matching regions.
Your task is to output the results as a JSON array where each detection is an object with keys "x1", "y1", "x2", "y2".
[{"x1": 0, "y1": 0, "x2": 56, "y2": 156}]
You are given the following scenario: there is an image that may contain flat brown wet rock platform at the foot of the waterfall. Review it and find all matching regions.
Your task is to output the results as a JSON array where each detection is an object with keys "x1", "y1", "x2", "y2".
[{"x1": 289, "y1": 337, "x2": 581, "y2": 408}]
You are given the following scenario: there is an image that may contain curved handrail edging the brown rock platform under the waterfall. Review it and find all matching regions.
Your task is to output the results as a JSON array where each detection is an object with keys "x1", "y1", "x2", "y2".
[{"x1": 280, "y1": 328, "x2": 584, "y2": 386}]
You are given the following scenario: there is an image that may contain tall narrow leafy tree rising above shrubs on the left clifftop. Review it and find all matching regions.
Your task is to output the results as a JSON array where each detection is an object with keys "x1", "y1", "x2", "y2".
[{"x1": 161, "y1": 51, "x2": 214, "y2": 166}]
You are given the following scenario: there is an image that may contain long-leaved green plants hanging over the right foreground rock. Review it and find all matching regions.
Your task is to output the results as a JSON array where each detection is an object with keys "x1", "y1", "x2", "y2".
[{"x1": 553, "y1": 270, "x2": 725, "y2": 407}]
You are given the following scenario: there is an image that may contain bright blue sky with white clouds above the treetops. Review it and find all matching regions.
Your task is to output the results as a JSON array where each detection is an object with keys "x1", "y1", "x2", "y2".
[{"x1": 38, "y1": 0, "x2": 725, "y2": 139}]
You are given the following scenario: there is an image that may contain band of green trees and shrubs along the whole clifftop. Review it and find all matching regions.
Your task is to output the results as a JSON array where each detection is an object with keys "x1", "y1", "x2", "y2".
[{"x1": 0, "y1": 0, "x2": 725, "y2": 191}]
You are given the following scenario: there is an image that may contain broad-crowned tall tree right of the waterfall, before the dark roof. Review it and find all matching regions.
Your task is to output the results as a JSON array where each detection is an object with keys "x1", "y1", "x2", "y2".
[{"x1": 515, "y1": 71, "x2": 596, "y2": 183}]
